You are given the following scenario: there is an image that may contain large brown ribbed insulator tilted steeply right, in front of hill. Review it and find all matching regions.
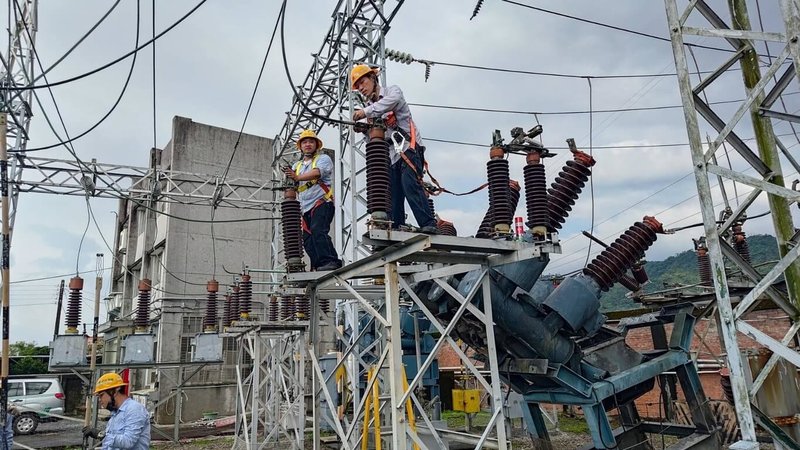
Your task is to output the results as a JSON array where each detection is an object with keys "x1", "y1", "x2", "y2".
[{"x1": 583, "y1": 217, "x2": 664, "y2": 291}]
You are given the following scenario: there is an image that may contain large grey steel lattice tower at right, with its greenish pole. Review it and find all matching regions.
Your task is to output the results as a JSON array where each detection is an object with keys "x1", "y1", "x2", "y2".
[{"x1": 665, "y1": 0, "x2": 800, "y2": 449}]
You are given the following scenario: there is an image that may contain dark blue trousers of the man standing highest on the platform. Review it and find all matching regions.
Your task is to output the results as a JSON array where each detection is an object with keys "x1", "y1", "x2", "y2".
[{"x1": 389, "y1": 150, "x2": 436, "y2": 228}]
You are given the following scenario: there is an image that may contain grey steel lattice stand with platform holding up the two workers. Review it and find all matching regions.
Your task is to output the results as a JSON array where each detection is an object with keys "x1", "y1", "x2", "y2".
[{"x1": 287, "y1": 230, "x2": 540, "y2": 450}]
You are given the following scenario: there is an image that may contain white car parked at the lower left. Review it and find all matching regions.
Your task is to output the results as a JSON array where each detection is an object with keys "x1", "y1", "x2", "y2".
[{"x1": 8, "y1": 378, "x2": 64, "y2": 435}]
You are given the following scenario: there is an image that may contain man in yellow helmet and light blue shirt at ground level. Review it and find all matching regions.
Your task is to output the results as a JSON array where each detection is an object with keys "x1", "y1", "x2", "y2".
[{"x1": 83, "y1": 372, "x2": 150, "y2": 450}]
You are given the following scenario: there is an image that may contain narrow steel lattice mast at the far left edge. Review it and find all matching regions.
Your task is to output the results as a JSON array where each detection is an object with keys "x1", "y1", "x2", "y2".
[{"x1": 0, "y1": 0, "x2": 39, "y2": 236}]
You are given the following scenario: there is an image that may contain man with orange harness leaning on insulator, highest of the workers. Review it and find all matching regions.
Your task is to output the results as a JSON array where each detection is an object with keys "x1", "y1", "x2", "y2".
[{"x1": 350, "y1": 64, "x2": 437, "y2": 234}]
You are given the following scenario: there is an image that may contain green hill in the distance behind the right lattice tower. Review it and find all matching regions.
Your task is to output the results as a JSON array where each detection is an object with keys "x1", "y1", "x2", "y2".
[{"x1": 588, "y1": 234, "x2": 778, "y2": 311}]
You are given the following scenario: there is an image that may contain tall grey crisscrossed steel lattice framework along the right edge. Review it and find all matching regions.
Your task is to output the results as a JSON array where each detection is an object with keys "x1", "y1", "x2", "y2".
[{"x1": 665, "y1": 0, "x2": 800, "y2": 448}]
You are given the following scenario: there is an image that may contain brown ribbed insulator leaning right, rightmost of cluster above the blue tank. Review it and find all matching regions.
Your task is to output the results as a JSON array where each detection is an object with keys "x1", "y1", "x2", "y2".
[{"x1": 547, "y1": 151, "x2": 595, "y2": 231}]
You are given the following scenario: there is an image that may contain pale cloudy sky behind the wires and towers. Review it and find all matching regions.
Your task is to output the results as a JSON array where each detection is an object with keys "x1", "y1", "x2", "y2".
[{"x1": 3, "y1": 0, "x2": 798, "y2": 344}]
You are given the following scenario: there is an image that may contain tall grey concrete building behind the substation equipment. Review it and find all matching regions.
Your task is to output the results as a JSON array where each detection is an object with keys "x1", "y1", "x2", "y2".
[{"x1": 100, "y1": 117, "x2": 273, "y2": 423}]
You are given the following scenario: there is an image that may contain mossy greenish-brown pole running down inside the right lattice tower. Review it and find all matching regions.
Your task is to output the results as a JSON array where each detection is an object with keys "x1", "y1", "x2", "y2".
[{"x1": 728, "y1": 0, "x2": 800, "y2": 308}]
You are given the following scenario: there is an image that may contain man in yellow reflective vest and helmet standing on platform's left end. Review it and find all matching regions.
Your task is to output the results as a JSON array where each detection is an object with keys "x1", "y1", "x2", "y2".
[{"x1": 284, "y1": 130, "x2": 342, "y2": 270}]
